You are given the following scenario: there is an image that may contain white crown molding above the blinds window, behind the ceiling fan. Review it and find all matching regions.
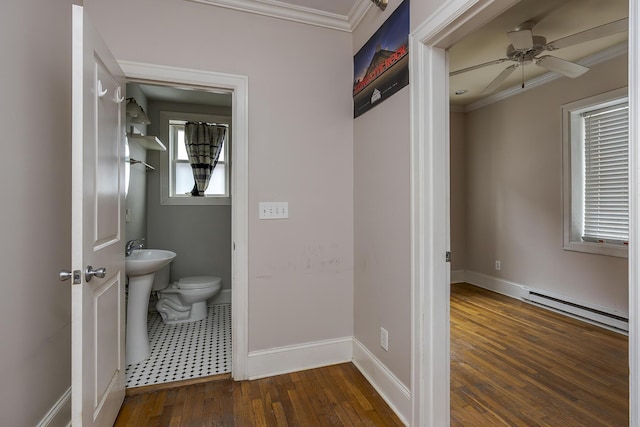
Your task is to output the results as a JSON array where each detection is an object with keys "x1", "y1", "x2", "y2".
[{"x1": 456, "y1": 41, "x2": 629, "y2": 113}]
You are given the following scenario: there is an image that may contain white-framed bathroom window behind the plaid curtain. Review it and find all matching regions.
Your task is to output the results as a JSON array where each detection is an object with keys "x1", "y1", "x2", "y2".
[{"x1": 160, "y1": 112, "x2": 231, "y2": 205}]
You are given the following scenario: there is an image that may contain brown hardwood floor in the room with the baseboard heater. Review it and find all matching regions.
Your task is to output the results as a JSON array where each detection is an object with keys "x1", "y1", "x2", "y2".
[{"x1": 451, "y1": 284, "x2": 629, "y2": 427}]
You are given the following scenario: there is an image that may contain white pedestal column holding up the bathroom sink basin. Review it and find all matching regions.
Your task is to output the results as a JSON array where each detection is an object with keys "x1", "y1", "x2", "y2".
[{"x1": 126, "y1": 272, "x2": 156, "y2": 365}]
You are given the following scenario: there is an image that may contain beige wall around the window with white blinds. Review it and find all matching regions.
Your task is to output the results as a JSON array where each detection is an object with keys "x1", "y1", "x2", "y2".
[{"x1": 462, "y1": 56, "x2": 628, "y2": 312}]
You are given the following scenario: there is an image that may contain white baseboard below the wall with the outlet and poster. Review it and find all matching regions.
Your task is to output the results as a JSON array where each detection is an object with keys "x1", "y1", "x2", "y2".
[{"x1": 353, "y1": 338, "x2": 411, "y2": 425}]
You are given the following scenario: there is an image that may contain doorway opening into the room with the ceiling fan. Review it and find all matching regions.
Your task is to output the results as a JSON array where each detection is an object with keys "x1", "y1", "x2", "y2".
[{"x1": 447, "y1": 0, "x2": 628, "y2": 424}]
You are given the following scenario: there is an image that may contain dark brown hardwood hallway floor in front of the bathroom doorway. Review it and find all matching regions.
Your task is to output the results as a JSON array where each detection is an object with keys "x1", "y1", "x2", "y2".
[{"x1": 115, "y1": 363, "x2": 403, "y2": 427}]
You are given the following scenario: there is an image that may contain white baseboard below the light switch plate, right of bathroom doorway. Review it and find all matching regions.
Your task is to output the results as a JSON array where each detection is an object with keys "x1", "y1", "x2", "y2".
[{"x1": 246, "y1": 336, "x2": 353, "y2": 380}]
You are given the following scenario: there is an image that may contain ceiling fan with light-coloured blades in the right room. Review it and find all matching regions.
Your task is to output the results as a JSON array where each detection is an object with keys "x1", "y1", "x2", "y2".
[{"x1": 449, "y1": 18, "x2": 629, "y2": 94}]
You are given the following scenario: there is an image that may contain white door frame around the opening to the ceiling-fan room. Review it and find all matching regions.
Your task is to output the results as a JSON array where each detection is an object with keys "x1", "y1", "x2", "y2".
[{"x1": 409, "y1": 0, "x2": 640, "y2": 427}]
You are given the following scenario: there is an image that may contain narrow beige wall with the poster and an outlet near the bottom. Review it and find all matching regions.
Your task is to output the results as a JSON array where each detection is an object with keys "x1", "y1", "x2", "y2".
[{"x1": 353, "y1": 0, "x2": 411, "y2": 387}]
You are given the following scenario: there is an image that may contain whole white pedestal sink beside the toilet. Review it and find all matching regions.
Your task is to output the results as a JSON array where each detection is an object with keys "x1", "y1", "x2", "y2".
[{"x1": 124, "y1": 249, "x2": 176, "y2": 365}]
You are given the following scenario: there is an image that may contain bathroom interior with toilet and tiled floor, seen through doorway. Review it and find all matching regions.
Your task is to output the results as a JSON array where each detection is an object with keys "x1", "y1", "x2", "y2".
[{"x1": 125, "y1": 82, "x2": 232, "y2": 388}]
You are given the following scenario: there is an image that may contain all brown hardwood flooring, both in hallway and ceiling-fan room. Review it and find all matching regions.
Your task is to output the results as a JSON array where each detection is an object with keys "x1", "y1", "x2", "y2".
[{"x1": 115, "y1": 284, "x2": 629, "y2": 427}]
